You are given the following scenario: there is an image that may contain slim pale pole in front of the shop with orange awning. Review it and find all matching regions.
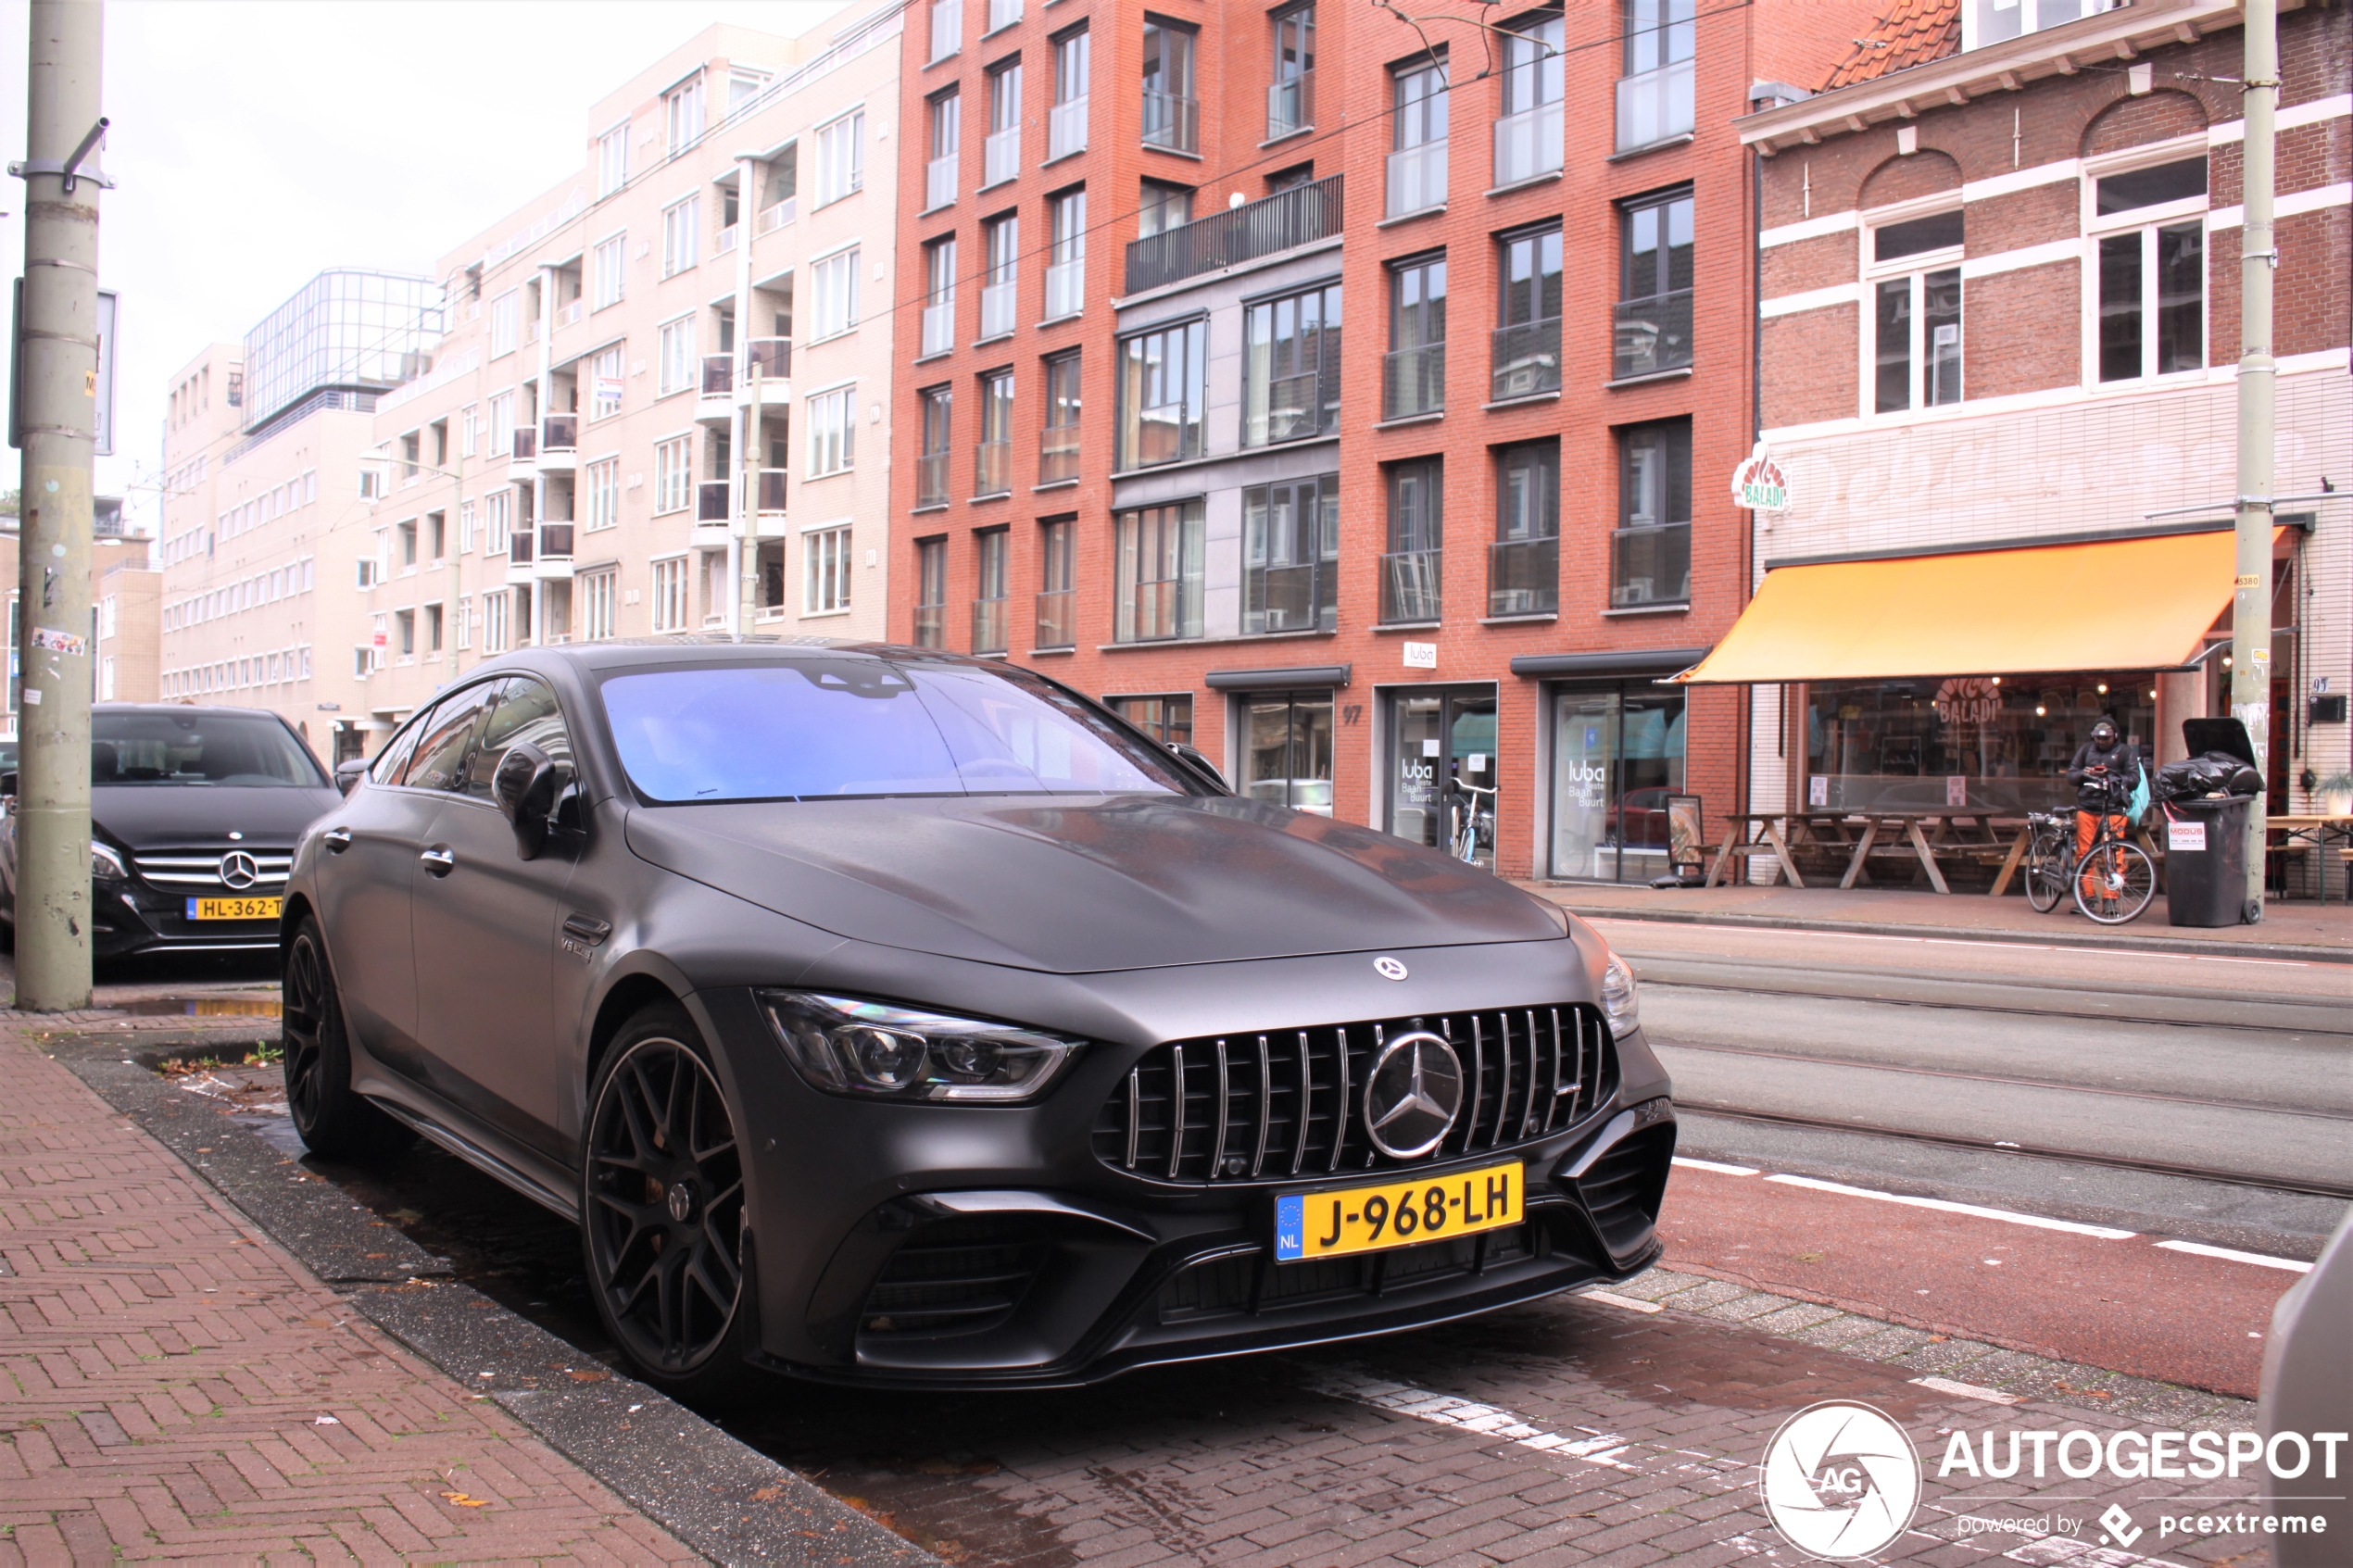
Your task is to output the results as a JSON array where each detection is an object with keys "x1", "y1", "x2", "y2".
[{"x1": 2231, "y1": 0, "x2": 2280, "y2": 924}]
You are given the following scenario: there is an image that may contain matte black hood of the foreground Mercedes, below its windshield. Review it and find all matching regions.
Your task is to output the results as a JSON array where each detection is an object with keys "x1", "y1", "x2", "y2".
[{"x1": 626, "y1": 795, "x2": 1560, "y2": 973}]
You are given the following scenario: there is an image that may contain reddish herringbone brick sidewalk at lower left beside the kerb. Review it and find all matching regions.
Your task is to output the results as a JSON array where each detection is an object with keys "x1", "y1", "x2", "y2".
[{"x1": 0, "y1": 1021, "x2": 694, "y2": 1565}]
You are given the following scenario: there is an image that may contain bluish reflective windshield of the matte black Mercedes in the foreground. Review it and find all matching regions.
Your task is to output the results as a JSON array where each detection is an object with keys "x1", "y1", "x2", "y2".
[{"x1": 605, "y1": 659, "x2": 1198, "y2": 802}]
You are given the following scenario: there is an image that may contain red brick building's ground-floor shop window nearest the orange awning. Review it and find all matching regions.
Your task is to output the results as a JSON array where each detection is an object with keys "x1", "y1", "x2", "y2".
[{"x1": 1553, "y1": 684, "x2": 1682, "y2": 882}]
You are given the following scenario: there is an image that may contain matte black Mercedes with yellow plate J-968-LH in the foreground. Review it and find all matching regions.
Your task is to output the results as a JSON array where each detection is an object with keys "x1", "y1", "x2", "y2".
[{"x1": 283, "y1": 639, "x2": 1675, "y2": 1399}]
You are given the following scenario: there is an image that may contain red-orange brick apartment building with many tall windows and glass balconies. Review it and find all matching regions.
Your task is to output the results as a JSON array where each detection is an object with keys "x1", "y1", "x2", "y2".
[{"x1": 889, "y1": 0, "x2": 1878, "y2": 879}]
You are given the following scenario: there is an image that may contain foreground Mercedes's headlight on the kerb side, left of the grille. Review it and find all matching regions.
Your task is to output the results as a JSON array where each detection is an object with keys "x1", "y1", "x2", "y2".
[{"x1": 760, "y1": 992, "x2": 1082, "y2": 1105}]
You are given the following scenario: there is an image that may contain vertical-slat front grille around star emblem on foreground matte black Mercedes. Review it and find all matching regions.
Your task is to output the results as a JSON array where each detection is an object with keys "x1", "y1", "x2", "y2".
[{"x1": 1094, "y1": 1004, "x2": 1617, "y2": 1183}]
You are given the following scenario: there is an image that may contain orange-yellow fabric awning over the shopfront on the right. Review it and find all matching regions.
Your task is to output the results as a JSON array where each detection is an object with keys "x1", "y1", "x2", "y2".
[{"x1": 1675, "y1": 529, "x2": 2235, "y2": 684}]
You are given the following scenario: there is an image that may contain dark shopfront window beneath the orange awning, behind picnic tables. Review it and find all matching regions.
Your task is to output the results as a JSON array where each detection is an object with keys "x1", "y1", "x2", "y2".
[{"x1": 1805, "y1": 670, "x2": 2158, "y2": 813}]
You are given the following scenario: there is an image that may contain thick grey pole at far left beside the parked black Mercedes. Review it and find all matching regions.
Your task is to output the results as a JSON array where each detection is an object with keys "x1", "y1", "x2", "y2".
[{"x1": 17, "y1": 0, "x2": 106, "y2": 1013}]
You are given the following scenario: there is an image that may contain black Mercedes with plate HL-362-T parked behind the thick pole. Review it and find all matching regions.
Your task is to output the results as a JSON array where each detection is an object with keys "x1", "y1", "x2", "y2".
[{"x1": 0, "y1": 703, "x2": 341, "y2": 960}]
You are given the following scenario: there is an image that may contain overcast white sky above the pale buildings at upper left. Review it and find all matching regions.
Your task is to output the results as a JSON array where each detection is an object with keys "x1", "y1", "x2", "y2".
[{"x1": 0, "y1": 0, "x2": 842, "y2": 521}]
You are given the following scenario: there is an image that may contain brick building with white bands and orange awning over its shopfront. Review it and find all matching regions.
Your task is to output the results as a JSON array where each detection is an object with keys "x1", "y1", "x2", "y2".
[{"x1": 1699, "y1": 0, "x2": 2353, "y2": 879}]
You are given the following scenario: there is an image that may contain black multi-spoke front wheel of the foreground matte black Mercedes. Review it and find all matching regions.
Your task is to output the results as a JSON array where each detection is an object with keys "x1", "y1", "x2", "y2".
[{"x1": 581, "y1": 1001, "x2": 758, "y2": 1406}]
